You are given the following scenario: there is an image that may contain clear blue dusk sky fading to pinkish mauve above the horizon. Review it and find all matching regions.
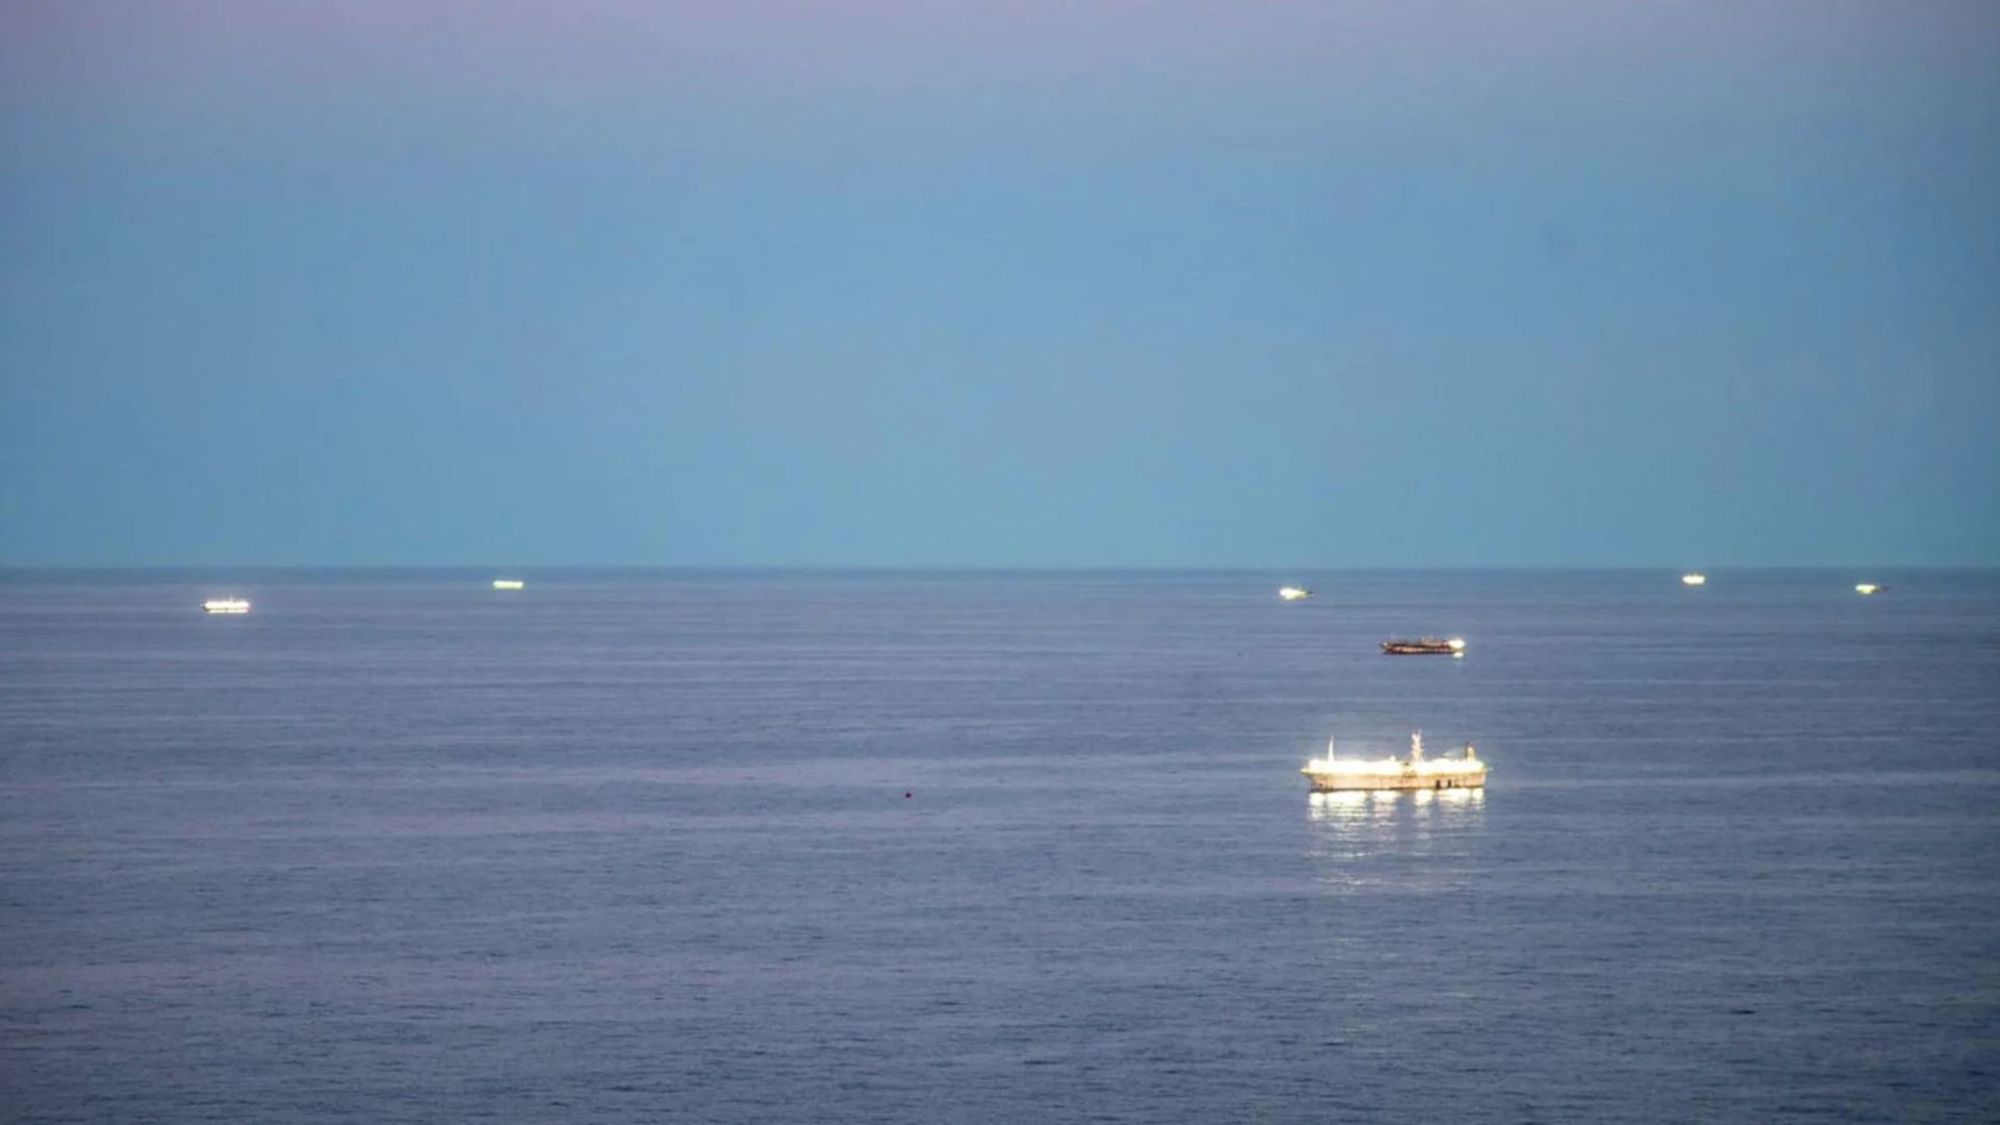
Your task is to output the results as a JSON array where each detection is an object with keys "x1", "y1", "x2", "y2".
[{"x1": 0, "y1": 0, "x2": 2000, "y2": 567}]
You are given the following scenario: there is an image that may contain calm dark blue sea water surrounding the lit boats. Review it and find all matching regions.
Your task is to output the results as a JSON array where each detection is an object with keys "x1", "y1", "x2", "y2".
[{"x1": 0, "y1": 571, "x2": 2000, "y2": 1123}]
